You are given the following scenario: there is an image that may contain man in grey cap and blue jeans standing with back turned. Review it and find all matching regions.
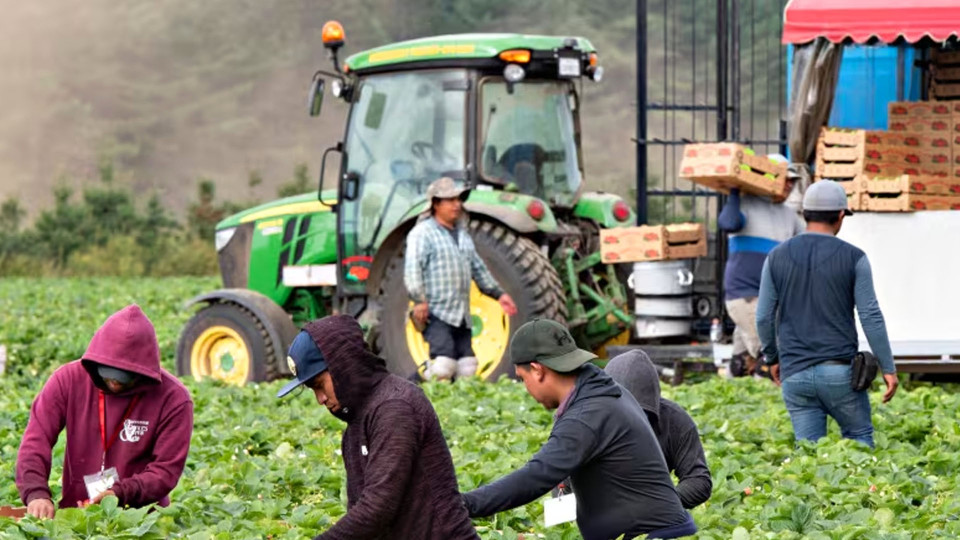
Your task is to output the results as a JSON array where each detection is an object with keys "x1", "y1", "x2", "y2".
[{"x1": 757, "y1": 180, "x2": 897, "y2": 446}]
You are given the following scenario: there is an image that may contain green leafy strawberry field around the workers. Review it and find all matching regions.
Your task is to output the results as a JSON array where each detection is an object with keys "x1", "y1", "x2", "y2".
[{"x1": 0, "y1": 279, "x2": 960, "y2": 540}]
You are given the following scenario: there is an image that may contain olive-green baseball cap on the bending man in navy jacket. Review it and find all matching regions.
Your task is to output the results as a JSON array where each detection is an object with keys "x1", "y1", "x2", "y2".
[{"x1": 510, "y1": 319, "x2": 597, "y2": 373}]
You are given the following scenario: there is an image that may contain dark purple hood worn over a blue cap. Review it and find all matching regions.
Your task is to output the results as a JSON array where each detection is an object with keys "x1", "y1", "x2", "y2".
[{"x1": 303, "y1": 315, "x2": 387, "y2": 423}]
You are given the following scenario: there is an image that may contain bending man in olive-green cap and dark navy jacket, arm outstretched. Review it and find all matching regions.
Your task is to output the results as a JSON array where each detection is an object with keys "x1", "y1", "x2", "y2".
[{"x1": 463, "y1": 319, "x2": 697, "y2": 540}]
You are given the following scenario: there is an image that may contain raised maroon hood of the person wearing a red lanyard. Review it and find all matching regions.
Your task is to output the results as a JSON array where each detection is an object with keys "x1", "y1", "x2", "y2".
[{"x1": 81, "y1": 304, "x2": 162, "y2": 394}]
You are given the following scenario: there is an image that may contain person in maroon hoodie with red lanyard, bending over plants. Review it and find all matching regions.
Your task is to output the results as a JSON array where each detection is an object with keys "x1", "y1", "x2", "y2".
[{"x1": 17, "y1": 305, "x2": 193, "y2": 518}]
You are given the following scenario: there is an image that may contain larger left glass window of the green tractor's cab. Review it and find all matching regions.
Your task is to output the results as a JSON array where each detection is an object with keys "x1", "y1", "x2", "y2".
[{"x1": 341, "y1": 70, "x2": 468, "y2": 255}]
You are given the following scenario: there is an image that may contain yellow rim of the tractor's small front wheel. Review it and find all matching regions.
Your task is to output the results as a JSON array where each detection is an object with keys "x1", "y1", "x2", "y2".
[{"x1": 190, "y1": 326, "x2": 251, "y2": 386}]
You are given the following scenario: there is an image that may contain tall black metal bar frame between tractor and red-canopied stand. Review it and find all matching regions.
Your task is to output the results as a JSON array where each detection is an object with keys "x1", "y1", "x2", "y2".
[{"x1": 636, "y1": 0, "x2": 787, "y2": 334}]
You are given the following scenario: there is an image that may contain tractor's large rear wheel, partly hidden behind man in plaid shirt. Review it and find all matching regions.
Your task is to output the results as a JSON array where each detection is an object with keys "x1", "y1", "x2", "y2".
[{"x1": 377, "y1": 220, "x2": 567, "y2": 381}]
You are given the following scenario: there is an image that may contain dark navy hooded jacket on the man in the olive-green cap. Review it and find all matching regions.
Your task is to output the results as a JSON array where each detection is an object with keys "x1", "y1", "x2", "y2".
[{"x1": 464, "y1": 364, "x2": 688, "y2": 540}]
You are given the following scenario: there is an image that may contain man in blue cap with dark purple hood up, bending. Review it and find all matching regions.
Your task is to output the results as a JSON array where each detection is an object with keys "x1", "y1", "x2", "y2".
[{"x1": 277, "y1": 315, "x2": 478, "y2": 540}]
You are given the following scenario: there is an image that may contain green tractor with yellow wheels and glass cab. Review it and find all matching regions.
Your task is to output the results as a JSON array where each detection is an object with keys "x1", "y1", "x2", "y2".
[{"x1": 177, "y1": 21, "x2": 635, "y2": 385}]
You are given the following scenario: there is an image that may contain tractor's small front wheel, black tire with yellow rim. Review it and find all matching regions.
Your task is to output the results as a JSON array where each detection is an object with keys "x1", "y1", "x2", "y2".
[{"x1": 177, "y1": 302, "x2": 279, "y2": 386}]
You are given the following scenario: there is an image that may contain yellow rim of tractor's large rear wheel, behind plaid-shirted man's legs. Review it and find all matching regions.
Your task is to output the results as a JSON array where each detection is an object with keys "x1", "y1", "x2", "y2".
[{"x1": 406, "y1": 283, "x2": 510, "y2": 379}]
